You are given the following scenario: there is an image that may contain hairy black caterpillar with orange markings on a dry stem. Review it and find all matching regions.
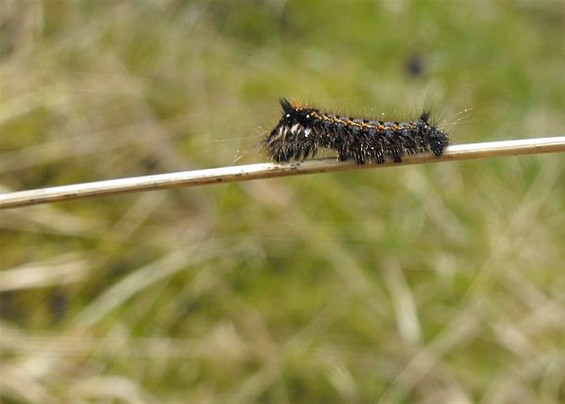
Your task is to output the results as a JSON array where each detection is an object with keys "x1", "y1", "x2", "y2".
[{"x1": 263, "y1": 98, "x2": 449, "y2": 164}]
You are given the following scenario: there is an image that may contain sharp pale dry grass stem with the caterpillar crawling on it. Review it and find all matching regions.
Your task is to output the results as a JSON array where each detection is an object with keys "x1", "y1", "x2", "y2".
[{"x1": 0, "y1": 136, "x2": 565, "y2": 209}]
